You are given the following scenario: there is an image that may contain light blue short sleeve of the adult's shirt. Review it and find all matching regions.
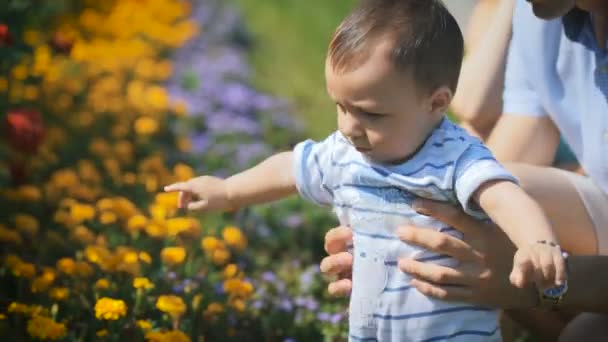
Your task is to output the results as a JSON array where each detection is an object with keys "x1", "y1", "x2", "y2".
[{"x1": 502, "y1": 1, "x2": 547, "y2": 117}]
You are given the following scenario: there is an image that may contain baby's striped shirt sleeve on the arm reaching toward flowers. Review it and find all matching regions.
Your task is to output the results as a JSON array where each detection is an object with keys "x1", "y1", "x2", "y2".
[{"x1": 293, "y1": 134, "x2": 335, "y2": 206}]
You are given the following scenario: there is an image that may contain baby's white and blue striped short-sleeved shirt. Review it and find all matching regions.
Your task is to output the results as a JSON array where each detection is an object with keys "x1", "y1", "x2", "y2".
[{"x1": 294, "y1": 118, "x2": 516, "y2": 341}]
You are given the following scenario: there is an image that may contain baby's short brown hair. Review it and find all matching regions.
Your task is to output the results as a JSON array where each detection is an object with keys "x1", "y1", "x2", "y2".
[{"x1": 328, "y1": 0, "x2": 464, "y2": 92}]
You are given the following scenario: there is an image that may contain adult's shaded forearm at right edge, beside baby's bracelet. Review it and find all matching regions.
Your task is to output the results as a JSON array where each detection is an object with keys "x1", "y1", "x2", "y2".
[{"x1": 561, "y1": 256, "x2": 608, "y2": 313}]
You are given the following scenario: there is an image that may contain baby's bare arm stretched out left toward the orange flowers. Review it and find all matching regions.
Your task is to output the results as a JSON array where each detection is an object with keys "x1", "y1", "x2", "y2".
[{"x1": 165, "y1": 152, "x2": 297, "y2": 211}]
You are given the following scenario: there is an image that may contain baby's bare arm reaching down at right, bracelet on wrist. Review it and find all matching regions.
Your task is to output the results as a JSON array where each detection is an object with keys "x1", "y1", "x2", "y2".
[{"x1": 475, "y1": 180, "x2": 566, "y2": 289}]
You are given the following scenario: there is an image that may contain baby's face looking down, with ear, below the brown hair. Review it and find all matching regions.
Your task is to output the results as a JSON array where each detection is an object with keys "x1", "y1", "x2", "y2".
[{"x1": 325, "y1": 38, "x2": 451, "y2": 163}]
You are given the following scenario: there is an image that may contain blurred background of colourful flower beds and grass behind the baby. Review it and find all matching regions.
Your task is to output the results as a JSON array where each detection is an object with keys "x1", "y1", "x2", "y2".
[{"x1": 0, "y1": 0, "x2": 528, "y2": 341}]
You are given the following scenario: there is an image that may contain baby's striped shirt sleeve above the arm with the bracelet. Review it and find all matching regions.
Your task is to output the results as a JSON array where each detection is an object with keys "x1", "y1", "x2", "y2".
[{"x1": 454, "y1": 143, "x2": 518, "y2": 219}]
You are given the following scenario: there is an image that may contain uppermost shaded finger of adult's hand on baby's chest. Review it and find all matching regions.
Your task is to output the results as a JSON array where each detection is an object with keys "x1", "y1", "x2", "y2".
[{"x1": 413, "y1": 199, "x2": 480, "y2": 235}]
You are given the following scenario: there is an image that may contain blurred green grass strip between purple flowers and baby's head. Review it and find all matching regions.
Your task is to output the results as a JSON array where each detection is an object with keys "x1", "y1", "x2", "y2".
[{"x1": 234, "y1": 0, "x2": 354, "y2": 139}]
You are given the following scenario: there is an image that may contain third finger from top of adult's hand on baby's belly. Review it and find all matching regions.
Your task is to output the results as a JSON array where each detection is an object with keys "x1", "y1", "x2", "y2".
[{"x1": 399, "y1": 258, "x2": 476, "y2": 285}]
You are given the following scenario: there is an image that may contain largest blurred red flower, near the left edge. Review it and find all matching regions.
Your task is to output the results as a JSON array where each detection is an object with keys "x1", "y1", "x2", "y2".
[{"x1": 5, "y1": 109, "x2": 45, "y2": 153}]
